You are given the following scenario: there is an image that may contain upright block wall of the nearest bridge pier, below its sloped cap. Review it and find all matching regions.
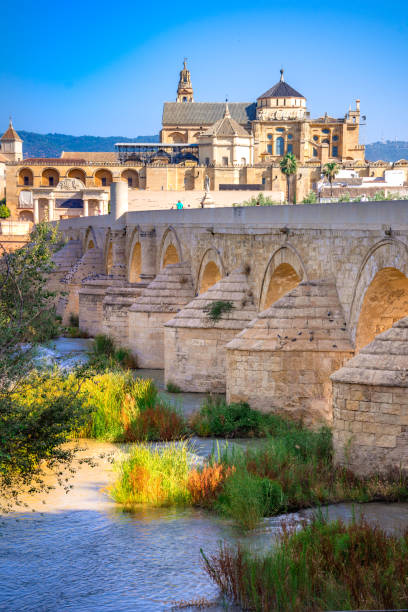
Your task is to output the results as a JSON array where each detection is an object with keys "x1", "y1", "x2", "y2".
[{"x1": 333, "y1": 382, "x2": 408, "y2": 475}]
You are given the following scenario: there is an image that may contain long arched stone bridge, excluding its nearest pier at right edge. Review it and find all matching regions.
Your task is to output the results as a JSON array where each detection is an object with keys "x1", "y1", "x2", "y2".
[{"x1": 54, "y1": 198, "x2": 408, "y2": 474}]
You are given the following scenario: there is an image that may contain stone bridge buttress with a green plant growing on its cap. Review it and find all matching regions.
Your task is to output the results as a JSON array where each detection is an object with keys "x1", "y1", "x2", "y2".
[{"x1": 165, "y1": 270, "x2": 256, "y2": 393}]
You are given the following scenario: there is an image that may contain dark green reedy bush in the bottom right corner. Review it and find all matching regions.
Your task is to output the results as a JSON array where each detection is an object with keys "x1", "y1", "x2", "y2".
[{"x1": 202, "y1": 516, "x2": 408, "y2": 612}]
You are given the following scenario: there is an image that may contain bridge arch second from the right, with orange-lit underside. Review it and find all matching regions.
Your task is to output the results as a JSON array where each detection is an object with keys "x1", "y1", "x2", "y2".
[{"x1": 259, "y1": 244, "x2": 308, "y2": 310}]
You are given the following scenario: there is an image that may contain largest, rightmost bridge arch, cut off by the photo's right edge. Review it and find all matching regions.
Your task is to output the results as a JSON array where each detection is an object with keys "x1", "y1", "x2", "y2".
[{"x1": 350, "y1": 238, "x2": 408, "y2": 351}]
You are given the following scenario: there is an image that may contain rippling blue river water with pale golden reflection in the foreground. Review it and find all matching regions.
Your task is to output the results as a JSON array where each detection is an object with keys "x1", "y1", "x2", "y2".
[{"x1": 0, "y1": 340, "x2": 408, "y2": 612}]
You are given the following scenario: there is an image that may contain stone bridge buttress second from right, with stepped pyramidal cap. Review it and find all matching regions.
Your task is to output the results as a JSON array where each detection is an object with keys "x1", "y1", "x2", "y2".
[{"x1": 227, "y1": 280, "x2": 354, "y2": 425}]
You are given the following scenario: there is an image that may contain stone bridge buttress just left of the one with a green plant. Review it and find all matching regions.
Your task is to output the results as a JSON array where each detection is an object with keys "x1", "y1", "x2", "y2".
[{"x1": 128, "y1": 263, "x2": 194, "y2": 368}]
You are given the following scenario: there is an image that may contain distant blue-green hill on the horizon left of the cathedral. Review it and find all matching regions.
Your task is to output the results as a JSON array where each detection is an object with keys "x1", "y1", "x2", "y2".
[{"x1": 17, "y1": 130, "x2": 159, "y2": 157}]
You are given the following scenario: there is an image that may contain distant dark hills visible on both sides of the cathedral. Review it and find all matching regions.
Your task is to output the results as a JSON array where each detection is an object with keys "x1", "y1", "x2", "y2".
[{"x1": 11, "y1": 130, "x2": 408, "y2": 162}]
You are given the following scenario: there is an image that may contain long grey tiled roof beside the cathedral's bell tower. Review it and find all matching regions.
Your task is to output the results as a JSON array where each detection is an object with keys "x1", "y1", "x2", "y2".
[{"x1": 162, "y1": 102, "x2": 256, "y2": 127}]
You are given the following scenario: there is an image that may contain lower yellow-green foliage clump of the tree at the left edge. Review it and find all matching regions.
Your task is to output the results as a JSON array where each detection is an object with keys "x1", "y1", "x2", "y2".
[{"x1": 0, "y1": 371, "x2": 87, "y2": 510}]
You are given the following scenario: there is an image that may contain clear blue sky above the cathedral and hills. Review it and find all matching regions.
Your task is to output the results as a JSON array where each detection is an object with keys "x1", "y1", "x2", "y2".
[{"x1": 0, "y1": 0, "x2": 408, "y2": 142}]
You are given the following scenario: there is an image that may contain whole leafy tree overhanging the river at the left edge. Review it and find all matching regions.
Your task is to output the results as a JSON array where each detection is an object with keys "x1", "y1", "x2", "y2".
[{"x1": 0, "y1": 224, "x2": 90, "y2": 509}]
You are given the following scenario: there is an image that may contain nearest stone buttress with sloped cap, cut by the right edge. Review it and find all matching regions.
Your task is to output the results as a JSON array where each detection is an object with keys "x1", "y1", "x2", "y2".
[{"x1": 331, "y1": 317, "x2": 408, "y2": 475}]
